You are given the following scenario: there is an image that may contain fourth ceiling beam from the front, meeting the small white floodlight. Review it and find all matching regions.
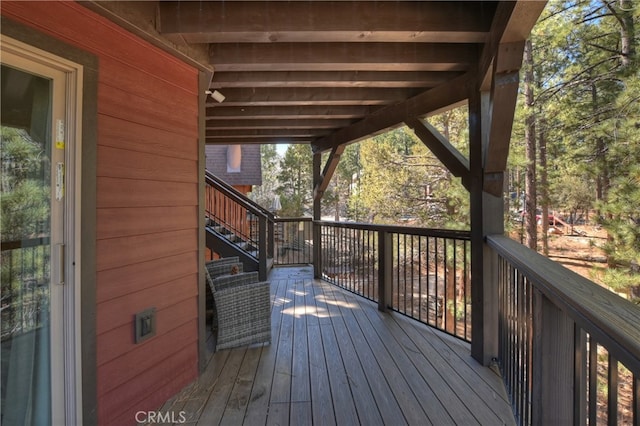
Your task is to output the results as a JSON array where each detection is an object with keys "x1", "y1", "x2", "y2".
[{"x1": 206, "y1": 87, "x2": 416, "y2": 106}]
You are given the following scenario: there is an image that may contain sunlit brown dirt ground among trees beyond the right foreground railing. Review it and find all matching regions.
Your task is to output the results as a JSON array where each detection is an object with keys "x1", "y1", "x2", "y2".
[{"x1": 514, "y1": 225, "x2": 607, "y2": 284}]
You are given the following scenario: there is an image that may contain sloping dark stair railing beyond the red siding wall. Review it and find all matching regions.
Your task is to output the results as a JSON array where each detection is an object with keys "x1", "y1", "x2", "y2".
[{"x1": 205, "y1": 171, "x2": 274, "y2": 262}]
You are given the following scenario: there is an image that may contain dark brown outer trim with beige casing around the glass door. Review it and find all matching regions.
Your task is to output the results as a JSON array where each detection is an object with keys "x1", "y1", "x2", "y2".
[{"x1": 0, "y1": 16, "x2": 98, "y2": 424}]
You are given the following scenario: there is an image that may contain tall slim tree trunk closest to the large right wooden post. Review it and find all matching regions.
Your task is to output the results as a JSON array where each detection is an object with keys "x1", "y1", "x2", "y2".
[{"x1": 523, "y1": 39, "x2": 538, "y2": 250}]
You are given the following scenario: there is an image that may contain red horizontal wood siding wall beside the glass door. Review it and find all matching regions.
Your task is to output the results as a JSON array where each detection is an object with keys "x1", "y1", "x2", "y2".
[{"x1": 2, "y1": 1, "x2": 198, "y2": 425}]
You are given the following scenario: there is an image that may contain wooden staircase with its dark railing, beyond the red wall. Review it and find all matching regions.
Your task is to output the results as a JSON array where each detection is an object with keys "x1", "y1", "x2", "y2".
[{"x1": 205, "y1": 172, "x2": 274, "y2": 281}]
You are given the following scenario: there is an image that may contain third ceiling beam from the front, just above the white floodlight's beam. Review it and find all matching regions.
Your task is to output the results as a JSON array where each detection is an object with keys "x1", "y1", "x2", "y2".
[{"x1": 209, "y1": 71, "x2": 461, "y2": 90}]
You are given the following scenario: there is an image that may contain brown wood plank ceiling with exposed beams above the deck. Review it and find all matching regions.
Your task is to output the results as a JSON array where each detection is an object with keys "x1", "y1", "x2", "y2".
[{"x1": 156, "y1": 1, "x2": 530, "y2": 151}]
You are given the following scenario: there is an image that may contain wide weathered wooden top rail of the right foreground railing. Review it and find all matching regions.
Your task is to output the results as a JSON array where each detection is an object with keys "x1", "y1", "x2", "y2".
[{"x1": 487, "y1": 235, "x2": 640, "y2": 371}]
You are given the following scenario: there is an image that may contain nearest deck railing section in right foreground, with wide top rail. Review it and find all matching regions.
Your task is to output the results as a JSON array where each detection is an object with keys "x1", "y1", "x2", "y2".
[{"x1": 488, "y1": 236, "x2": 640, "y2": 425}]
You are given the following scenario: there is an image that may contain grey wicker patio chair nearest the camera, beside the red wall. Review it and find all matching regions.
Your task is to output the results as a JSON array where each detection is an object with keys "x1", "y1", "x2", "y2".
[{"x1": 206, "y1": 272, "x2": 271, "y2": 350}]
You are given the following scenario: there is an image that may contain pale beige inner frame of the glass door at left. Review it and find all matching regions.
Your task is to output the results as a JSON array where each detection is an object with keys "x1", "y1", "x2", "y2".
[{"x1": 0, "y1": 36, "x2": 83, "y2": 424}]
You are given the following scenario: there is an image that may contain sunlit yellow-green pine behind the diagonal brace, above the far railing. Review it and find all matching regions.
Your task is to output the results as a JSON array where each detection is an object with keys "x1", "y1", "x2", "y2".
[{"x1": 352, "y1": 108, "x2": 469, "y2": 229}]
